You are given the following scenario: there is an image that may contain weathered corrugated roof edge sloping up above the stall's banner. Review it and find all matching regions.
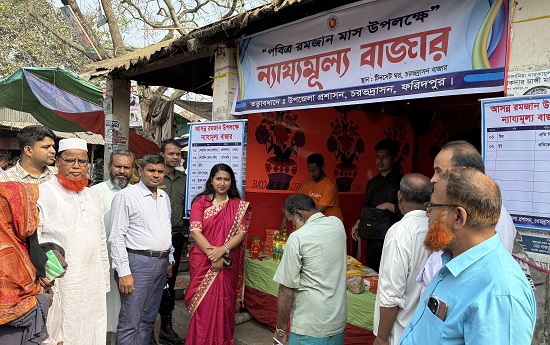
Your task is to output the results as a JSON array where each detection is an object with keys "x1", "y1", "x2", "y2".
[{"x1": 79, "y1": 0, "x2": 312, "y2": 80}]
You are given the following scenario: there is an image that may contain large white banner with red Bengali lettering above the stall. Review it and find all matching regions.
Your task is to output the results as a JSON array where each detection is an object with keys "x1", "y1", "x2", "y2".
[{"x1": 232, "y1": 0, "x2": 508, "y2": 115}]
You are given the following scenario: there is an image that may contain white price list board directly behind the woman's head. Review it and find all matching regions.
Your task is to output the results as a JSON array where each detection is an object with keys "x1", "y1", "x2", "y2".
[{"x1": 185, "y1": 120, "x2": 246, "y2": 218}]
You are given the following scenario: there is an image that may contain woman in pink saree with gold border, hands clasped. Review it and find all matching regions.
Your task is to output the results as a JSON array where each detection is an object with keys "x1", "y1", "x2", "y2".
[{"x1": 185, "y1": 164, "x2": 251, "y2": 345}]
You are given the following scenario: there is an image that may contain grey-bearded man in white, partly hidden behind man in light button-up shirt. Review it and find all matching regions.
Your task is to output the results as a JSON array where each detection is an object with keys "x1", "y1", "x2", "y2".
[{"x1": 90, "y1": 150, "x2": 135, "y2": 344}]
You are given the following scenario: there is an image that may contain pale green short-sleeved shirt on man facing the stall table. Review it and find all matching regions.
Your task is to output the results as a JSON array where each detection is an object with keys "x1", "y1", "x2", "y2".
[{"x1": 273, "y1": 212, "x2": 348, "y2": 338}]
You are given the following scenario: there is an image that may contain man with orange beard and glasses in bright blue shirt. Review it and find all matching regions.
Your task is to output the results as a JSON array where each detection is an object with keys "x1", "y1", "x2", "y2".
[{"x1": 399, "y1": 168, "x2": 536, "y2": 345}]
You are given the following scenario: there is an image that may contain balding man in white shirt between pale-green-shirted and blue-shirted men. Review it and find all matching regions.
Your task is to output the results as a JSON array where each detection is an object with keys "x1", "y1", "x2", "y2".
[{"x1": 374, "y1": 174, "x2": 433, "y2": 345}]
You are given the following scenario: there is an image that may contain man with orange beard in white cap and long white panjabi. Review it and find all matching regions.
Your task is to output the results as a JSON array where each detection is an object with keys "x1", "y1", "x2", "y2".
[{"x1": 38, "y1": 138, "x2": 110, "y2": 345}]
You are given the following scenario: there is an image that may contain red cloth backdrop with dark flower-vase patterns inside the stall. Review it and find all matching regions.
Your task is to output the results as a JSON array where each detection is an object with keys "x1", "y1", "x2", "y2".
[{"x1": 246, "y1": 108, "x2": 413, "y2": 194}]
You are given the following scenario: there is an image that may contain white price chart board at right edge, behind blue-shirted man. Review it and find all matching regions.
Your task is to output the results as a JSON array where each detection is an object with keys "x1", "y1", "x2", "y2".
[{"x1": 482, "y1": 95, "x2": 550, "y2": 230}]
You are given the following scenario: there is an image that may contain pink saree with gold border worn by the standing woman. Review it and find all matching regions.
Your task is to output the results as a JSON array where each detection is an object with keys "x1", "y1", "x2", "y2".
[{"x1": 185, "y1": 195, "x2": 251, "y2": 345}]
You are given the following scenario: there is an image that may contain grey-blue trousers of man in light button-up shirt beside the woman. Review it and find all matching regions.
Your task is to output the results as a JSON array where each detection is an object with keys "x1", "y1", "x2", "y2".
[{"x1": 115, "y1": 253, "x2": 168, "y2": 345}]
